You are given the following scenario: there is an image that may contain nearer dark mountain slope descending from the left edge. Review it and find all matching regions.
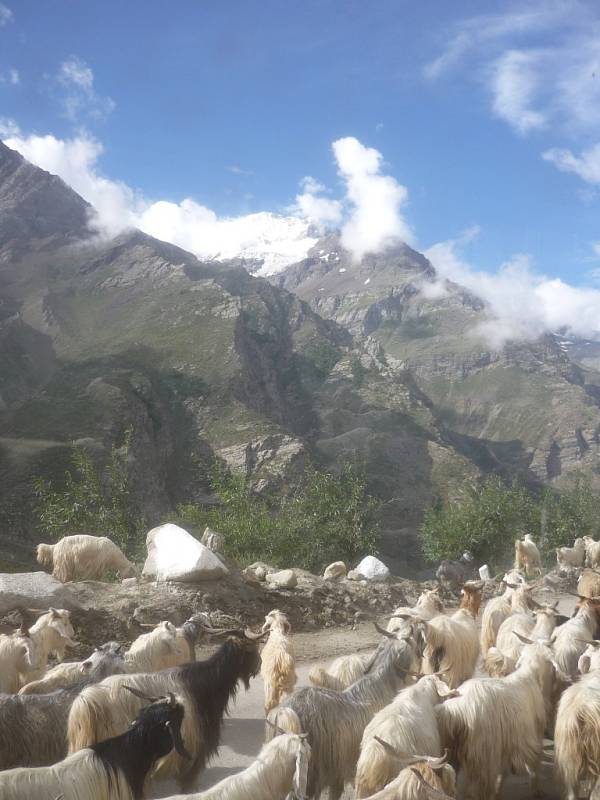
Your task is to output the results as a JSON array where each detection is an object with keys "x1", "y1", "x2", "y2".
[{"x1": 0, "y1": 144, "x2": 479, "y2": 569}]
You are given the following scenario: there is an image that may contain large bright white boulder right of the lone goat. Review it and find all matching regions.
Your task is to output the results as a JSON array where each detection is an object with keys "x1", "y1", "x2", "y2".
[{"x1": 142, "y1": 523, "x2": 229, "y2": 583}]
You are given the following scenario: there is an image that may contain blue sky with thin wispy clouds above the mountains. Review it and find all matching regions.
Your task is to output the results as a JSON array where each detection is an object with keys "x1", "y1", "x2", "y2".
[{"x1": 0, "y1": 0, "x2": 600, "y2": 326}]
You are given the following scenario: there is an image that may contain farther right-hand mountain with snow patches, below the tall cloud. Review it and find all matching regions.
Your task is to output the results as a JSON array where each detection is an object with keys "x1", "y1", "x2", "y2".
[{"x1": 272, "y1": 235, "x2": 600, "y2": 485}]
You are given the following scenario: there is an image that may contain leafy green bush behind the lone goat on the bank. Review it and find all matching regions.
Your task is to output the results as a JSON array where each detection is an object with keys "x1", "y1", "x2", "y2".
[{"x1": 34, "y1": 431, "x2": 145, "y2": 556}]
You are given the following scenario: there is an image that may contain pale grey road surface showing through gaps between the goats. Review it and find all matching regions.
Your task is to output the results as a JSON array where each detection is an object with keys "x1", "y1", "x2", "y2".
[{"x1": 148, "y1": 596, "x2": 574, "y2": 800}]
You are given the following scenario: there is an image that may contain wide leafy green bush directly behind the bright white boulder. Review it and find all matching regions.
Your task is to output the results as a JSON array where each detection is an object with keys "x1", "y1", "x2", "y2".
[{"x1": 178, "y1": 464, "x2": 379, "y2": 572}]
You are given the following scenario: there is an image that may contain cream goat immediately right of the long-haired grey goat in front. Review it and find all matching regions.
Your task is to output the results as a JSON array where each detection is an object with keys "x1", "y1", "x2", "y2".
[{"x1": 355, "y1": 675, "x2": 456, "y2": 797}]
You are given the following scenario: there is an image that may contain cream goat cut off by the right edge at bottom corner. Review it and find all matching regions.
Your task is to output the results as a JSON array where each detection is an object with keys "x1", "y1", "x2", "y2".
[{"x1": 554, "y1": 642, "x2": 600, "y2": 800}]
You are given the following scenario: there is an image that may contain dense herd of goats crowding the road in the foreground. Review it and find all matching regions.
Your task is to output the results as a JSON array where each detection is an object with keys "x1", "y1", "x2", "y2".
[{"x1": 0, "y1": 537, "x2": 600, "y2": 800}]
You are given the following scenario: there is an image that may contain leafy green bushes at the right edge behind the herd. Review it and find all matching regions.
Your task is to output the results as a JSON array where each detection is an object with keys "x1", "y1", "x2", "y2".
[{"x1": 421, "y1": 475, "x2": 600, "y2": 566}]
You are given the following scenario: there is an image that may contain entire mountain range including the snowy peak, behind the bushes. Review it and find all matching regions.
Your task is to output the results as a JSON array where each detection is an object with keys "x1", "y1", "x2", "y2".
[{"x1": 0, "y1": 144, "x2": 600, "y2": 572}]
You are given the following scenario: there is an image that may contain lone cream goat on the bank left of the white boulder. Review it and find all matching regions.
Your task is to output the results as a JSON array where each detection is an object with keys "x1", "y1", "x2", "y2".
[{"x1": 37, "y1": 534, "x2": 135, "y2": 583}]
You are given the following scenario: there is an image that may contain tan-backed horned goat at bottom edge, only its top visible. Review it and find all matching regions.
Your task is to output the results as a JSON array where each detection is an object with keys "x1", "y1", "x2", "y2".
[{"x1": 358, "y1": 752, "x2": 456, "y2": 800}]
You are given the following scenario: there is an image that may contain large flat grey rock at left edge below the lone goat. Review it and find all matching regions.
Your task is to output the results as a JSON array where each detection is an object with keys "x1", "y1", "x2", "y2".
[{"x1": 0, "y1": 572, "x2": 82, "y2": 614}]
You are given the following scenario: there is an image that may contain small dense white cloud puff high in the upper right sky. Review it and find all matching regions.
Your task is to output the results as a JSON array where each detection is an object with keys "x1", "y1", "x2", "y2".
[{"x1": 490, "y1": 50, "x2": 546, "y2": 133}]
